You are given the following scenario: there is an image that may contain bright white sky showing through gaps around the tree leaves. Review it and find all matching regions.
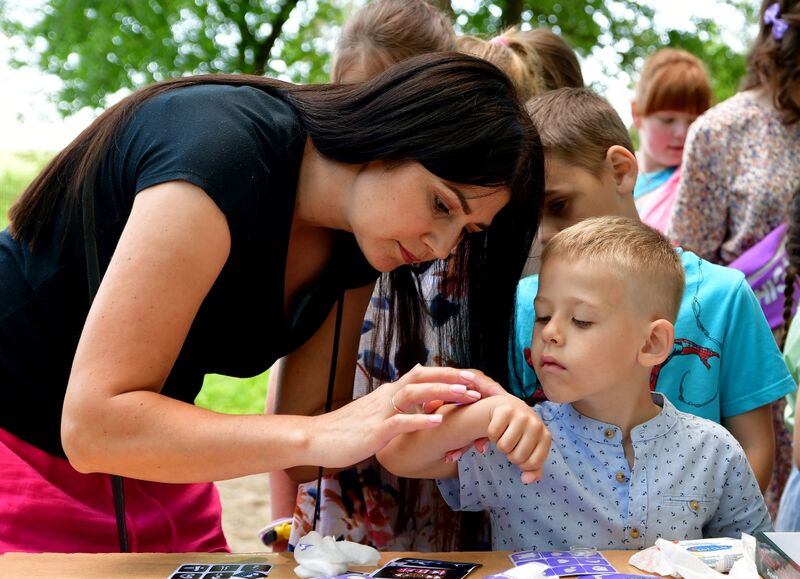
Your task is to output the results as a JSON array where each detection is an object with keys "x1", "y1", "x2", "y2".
[{"x1": 0, "y1": 0, "x2": 756, "y2": 151}]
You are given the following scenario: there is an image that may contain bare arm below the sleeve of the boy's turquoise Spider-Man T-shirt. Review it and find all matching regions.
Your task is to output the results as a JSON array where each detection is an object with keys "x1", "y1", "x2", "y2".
[{"x1": 722, "y1": 404, "x2": 775, "y2": 493}]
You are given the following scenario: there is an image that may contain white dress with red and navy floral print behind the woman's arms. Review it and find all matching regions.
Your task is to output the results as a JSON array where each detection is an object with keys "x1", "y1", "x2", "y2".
[{"x1": 289, "y1": 264, "x2": 488, "y2": 551}]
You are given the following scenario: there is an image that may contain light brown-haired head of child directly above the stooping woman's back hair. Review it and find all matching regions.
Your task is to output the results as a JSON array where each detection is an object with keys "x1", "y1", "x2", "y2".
[{"x1": 331, "y1": 0, "x2": 455, "y2": 82}]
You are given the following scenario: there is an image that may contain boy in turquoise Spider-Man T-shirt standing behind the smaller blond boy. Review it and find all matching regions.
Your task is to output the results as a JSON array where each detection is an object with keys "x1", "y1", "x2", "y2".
[{"x1": 509, "y1": 89, "x2": 795, "y2": 491}]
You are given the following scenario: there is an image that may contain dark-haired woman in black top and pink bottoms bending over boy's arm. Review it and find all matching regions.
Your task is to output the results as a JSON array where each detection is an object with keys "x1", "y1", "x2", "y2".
[{"x1": 0, "y1": 53, "x2": 542, "y2": 551}]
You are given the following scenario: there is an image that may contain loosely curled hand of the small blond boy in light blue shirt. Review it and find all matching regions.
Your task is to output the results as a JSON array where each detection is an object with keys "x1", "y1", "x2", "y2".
[{"x1": 486, "y1": 394, "x2": 552, "y2": 484}]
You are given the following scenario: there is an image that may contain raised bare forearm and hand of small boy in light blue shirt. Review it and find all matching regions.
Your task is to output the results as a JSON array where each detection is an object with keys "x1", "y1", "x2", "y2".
[{"x1": 377, "y1": 394, "x2": 550, "y2": 482}]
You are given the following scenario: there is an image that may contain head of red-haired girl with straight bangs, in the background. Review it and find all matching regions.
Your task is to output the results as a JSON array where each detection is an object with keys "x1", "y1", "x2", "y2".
[{"x1": 631, "y1": 48, "x2": 711, "y2": 171}]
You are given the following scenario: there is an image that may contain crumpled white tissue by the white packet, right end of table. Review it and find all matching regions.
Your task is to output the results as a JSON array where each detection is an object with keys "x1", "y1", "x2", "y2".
[{"x1": 629, "y1": 533, "x2": 759, "y2": 579}]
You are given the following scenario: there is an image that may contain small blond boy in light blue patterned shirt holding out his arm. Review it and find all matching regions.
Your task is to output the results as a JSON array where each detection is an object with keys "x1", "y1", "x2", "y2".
[{"x1": 378, "y1": 217, "x2": 771, "y2": 550}]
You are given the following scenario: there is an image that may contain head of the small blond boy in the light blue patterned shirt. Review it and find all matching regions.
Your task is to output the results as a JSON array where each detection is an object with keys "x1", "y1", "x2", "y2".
[{"x1": 531, "y1": 217, "x2": 684, "y2": 402}]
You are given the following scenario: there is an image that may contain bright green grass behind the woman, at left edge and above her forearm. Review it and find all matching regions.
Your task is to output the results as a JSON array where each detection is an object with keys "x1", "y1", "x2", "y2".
[{"x1": 0, "y1": 150, "x2": 269, "y2": 414}]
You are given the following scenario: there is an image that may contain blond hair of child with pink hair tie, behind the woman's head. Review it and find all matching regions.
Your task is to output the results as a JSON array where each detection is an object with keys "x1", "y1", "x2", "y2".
[{"x1": 456, "y1": 31, "x2": 545, "y2": 102}]
